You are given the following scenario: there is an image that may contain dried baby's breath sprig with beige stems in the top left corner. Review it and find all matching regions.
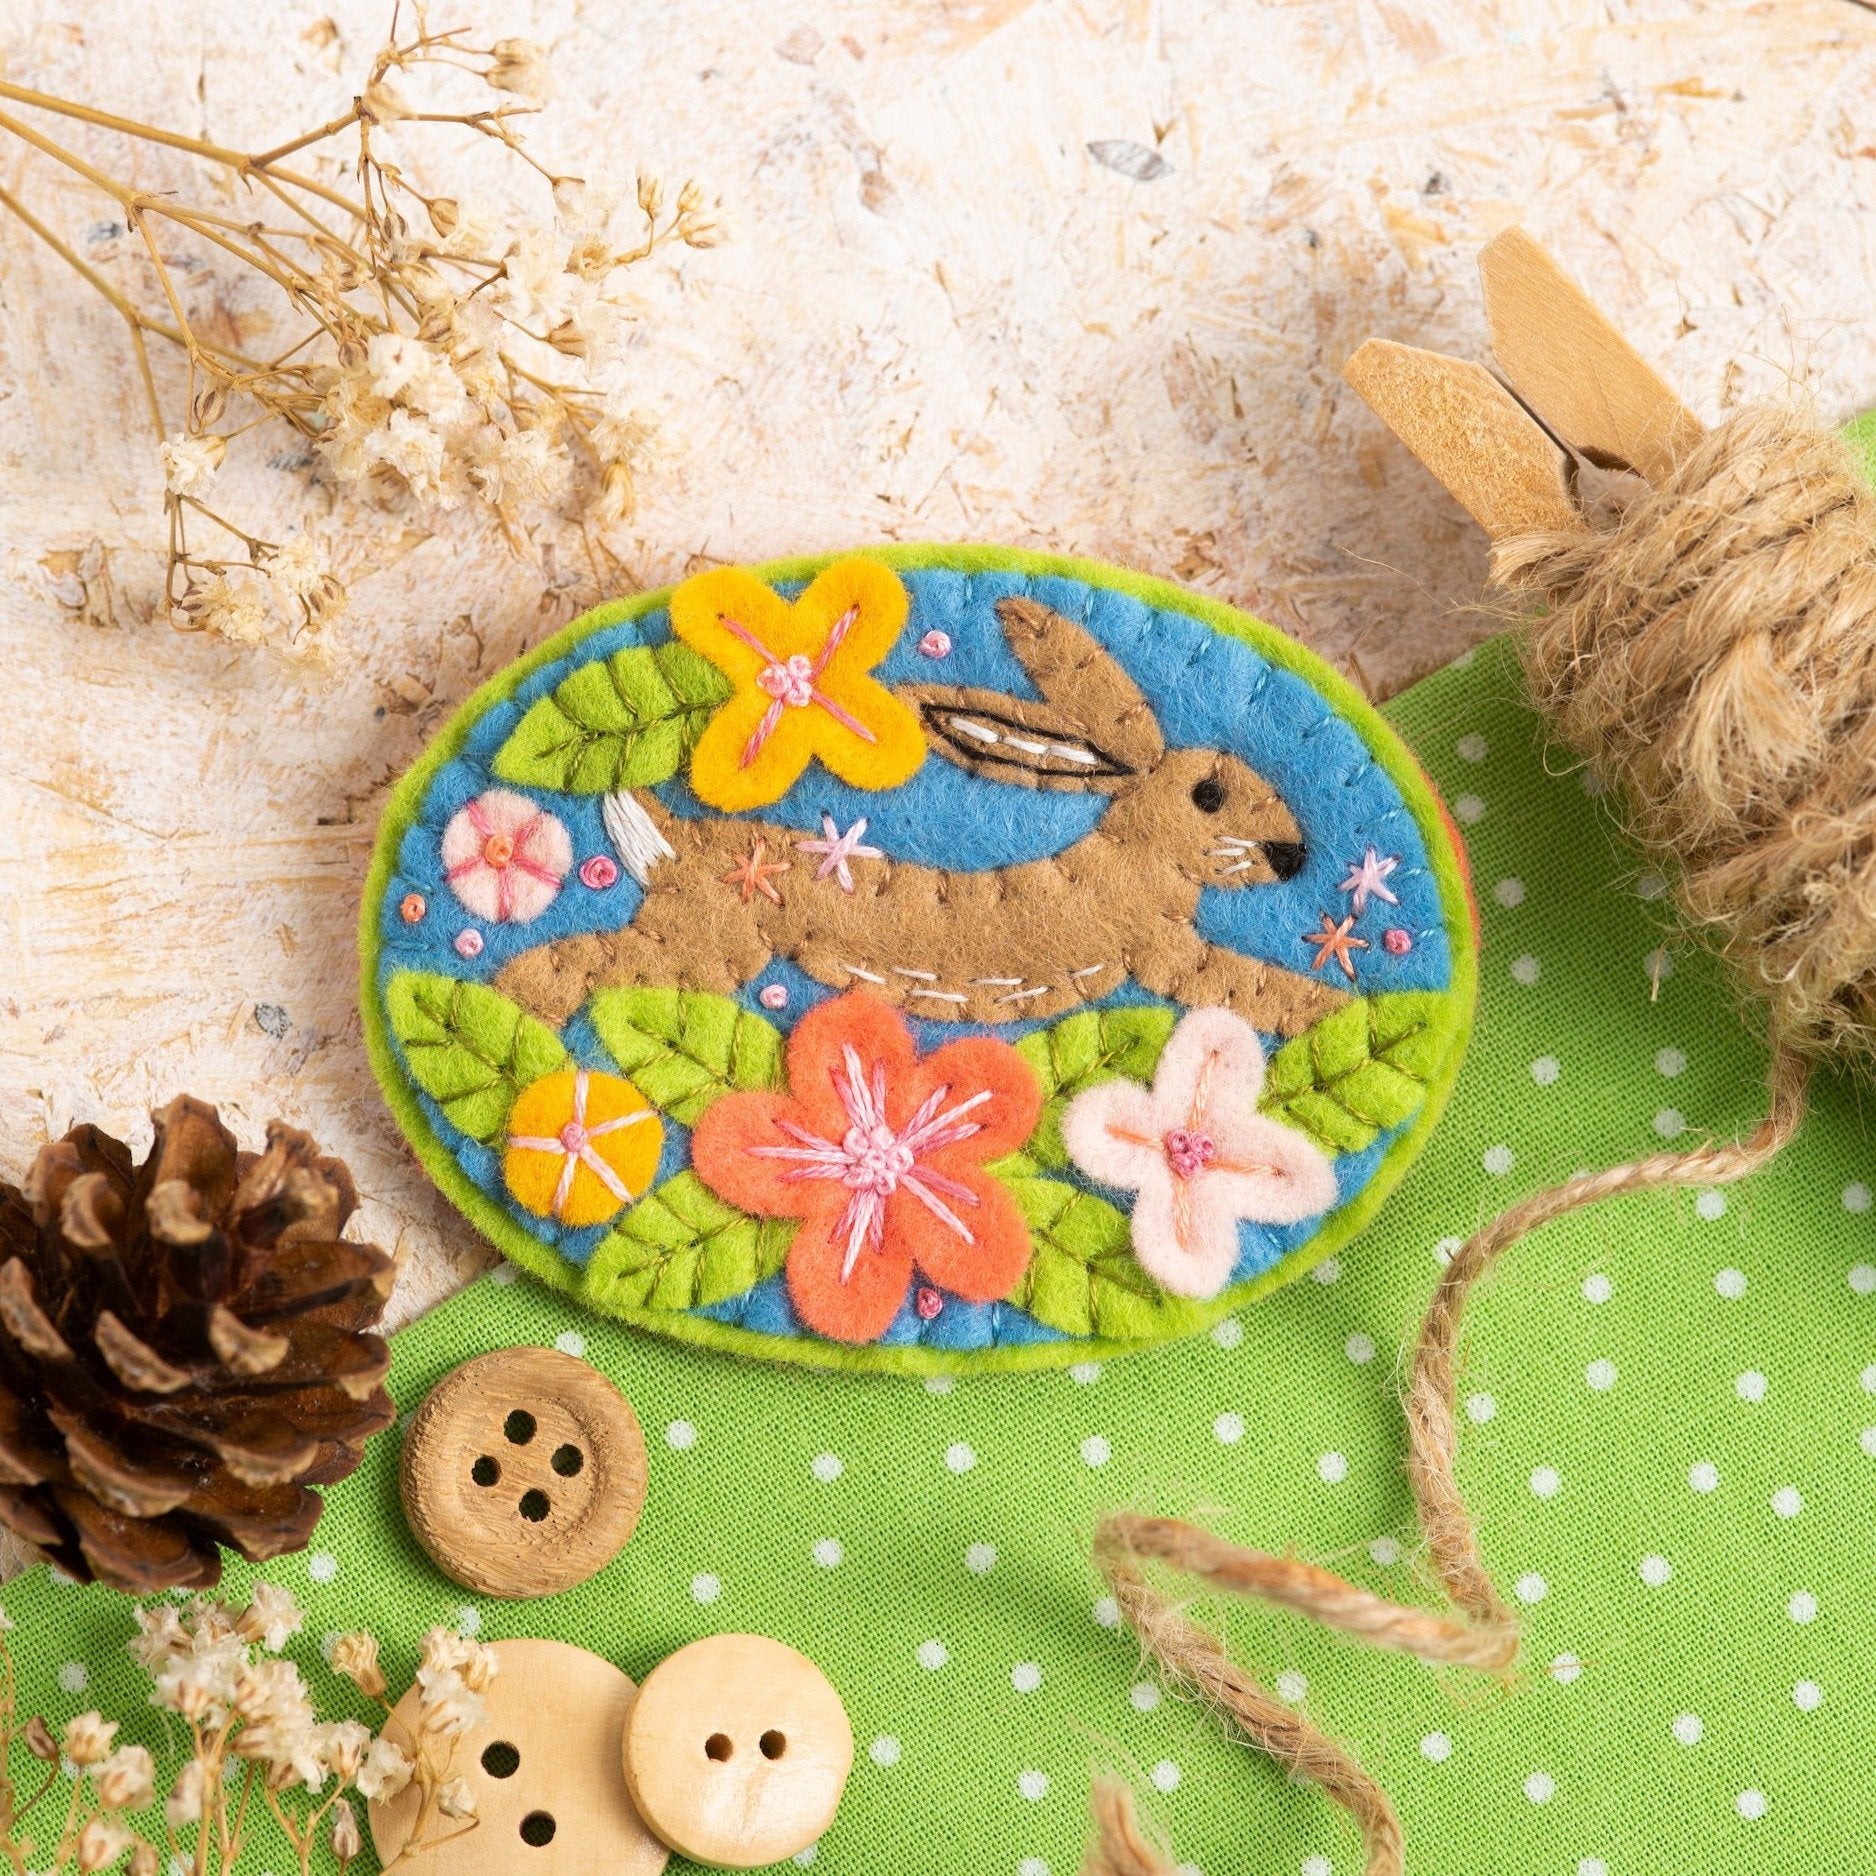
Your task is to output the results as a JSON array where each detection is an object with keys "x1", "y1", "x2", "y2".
[{"x1": 0, "y1": 15, "x2": 722, "y2": 660}]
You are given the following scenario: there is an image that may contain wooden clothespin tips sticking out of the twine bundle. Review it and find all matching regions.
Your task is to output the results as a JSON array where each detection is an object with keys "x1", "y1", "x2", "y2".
[{"x1": 1343, "y1": 229, "x2": 1702, "y2": 540}]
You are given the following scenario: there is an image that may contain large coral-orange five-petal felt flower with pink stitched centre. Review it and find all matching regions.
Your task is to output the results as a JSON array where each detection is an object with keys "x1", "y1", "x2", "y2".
[{"x1": 690, "y1": 991, "x2": 1041, "y2": 1341}]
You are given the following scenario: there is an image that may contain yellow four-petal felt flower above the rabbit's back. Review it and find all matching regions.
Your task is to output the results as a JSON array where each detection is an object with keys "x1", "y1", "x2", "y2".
[{"x1": 672, "y1": 559, "x2": 925, "y2": 812}]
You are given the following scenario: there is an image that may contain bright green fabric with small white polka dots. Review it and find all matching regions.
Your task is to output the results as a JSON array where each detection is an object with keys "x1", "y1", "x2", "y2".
[{"x1": 6, "y1": 645, "x2": 1876, "y2": 1876}]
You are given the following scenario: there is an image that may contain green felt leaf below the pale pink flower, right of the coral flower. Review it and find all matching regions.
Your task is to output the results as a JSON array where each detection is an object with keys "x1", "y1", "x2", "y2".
[{"x1": 1004, "y1": 1161, "x2": 1203, "y2": 1341}]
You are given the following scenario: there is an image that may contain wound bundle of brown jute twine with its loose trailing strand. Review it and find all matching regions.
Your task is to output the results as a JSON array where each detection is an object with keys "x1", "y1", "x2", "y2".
[{"x1": 1084, "y1": 407, "x2": 1876, "y2": 1876}]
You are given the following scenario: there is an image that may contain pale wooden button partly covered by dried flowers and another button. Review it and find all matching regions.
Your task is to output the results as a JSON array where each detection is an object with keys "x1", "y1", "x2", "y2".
[{"x1": 370, "y1": 1642, "x2": 670, "y2": 1876}]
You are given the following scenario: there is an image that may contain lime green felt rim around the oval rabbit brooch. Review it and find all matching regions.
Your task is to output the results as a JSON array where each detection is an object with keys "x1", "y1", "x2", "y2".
[{"x1": 358, "y1": 544, "x2": 1478, "y2": 1375}]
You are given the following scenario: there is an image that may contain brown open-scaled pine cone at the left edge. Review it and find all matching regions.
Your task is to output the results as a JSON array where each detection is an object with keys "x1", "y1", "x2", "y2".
[{"x1": 0, "y1": 1096, "x2": 396, "y2": 1595}]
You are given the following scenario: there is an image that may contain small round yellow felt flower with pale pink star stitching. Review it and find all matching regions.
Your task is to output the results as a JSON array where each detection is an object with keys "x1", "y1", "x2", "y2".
[{"x1": 501, "y1": 1067, "x2": 664, "y2": 1225}]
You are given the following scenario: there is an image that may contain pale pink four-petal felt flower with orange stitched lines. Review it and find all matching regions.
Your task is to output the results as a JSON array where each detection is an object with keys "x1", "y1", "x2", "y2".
[{"x1": 1062, "y1": 1009, "x2": 1336, "y2": 1296}]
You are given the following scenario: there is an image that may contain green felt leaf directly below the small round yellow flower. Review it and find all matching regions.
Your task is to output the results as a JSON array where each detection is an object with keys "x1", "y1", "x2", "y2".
[{"x1": 583, "y1": 1171, "x2": 795, "y2": 1309}]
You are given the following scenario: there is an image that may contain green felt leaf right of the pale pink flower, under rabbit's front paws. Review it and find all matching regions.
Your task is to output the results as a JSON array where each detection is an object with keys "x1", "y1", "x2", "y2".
[{"x1": 1257, "y1": 991, "x2": 1445, "y2": 1154}]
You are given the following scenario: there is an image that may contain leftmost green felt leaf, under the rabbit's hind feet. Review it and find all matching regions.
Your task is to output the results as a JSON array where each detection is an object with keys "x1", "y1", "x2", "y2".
[{"x1": 385, "y1": 970, "x2": 567, "y2": 1146}]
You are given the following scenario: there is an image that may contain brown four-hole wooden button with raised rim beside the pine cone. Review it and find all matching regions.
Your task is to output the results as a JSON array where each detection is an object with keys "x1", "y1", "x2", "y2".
[{"x1": 400, "y1": 1349, "x2": 645, "y2": 1596}]
